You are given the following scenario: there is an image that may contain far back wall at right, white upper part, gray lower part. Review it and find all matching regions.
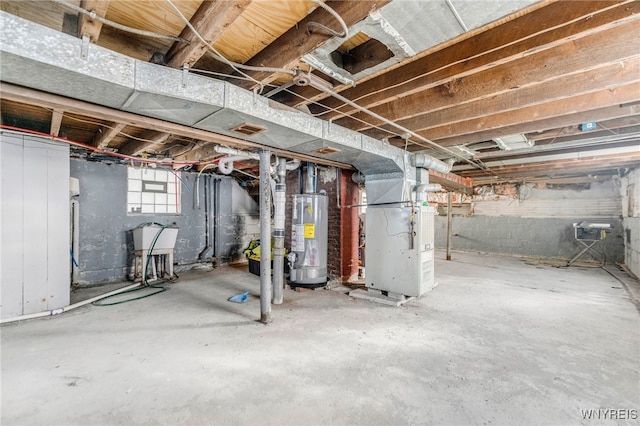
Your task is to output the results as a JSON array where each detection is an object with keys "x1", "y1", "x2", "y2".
[{"x1": 436, "y1": 180, "x2": 625, "y2": 263}]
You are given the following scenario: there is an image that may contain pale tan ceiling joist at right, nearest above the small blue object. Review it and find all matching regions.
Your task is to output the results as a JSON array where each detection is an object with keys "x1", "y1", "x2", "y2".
[{"x1": 417, "y1": 83, "x2": 640, "y2": 146}]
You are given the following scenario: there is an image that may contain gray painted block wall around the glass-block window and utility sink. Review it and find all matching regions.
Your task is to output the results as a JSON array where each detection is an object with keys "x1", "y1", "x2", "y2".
[{"x1": 70, "y1": 159, "x2": 252, "y2": 286}]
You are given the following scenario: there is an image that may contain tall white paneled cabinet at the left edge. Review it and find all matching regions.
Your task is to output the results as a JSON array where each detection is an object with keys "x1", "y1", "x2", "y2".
[{"x1": 0, "y1": 132, "x2": 70, "y2": 319}]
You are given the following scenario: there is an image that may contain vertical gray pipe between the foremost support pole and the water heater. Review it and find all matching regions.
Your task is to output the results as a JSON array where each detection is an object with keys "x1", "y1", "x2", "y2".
[{"x1": 273, "y1": 158, "x2": 287, "y2": 305}]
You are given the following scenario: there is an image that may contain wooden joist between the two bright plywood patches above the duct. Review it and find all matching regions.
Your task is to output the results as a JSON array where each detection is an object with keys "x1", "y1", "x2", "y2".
[{"x1": 166, "y1": 0, "x2": 251, "y2": 68}]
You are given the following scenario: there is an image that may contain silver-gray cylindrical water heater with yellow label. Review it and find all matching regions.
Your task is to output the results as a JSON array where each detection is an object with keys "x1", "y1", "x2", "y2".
[{"x1": 288, "y1": 194, "x2": 328, "y2": 287}]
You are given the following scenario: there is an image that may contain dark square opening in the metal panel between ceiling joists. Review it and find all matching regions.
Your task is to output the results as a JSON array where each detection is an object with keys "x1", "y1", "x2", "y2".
[{"x1": 331, "y1": 32, "x2": 394, "y2": 75}]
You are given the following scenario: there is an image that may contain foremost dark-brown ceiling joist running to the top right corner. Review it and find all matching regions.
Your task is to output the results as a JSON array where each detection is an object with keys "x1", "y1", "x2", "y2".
[{"x1": 284, "y1": 1, "x2": 638, "y2": 112}]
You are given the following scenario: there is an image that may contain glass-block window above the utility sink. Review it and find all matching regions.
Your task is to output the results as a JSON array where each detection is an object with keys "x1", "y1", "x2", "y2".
[{"x1": 127, "y1": 167, "x2": 180, "y2": 215}]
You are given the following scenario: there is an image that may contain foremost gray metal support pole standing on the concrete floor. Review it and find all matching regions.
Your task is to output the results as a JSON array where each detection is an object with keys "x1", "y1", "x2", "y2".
[{"x1": 260, "y1": 150, "x2": 271, "y2": 324}]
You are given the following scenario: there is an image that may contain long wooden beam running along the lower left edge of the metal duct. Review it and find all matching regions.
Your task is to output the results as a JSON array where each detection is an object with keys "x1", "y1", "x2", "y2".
[{"x1": 0, "y1": 81, "x2": 353, "y2": 170}]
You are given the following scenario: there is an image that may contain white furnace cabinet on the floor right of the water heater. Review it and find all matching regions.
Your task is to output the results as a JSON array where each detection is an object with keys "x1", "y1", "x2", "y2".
[{"x1": 365, "y1": 203, "x2": 435, "y2": 296}]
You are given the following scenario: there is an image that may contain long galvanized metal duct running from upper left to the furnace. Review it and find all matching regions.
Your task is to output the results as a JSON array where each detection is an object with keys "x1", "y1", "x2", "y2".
[{"x1": 0, "y1": 12, "x2": 404, "y2": 179}]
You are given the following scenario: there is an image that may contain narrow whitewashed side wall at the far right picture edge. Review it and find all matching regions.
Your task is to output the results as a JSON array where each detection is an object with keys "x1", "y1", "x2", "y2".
[{"x1": 620, "y1": 168, "x2": 640, "y2": 277}]
